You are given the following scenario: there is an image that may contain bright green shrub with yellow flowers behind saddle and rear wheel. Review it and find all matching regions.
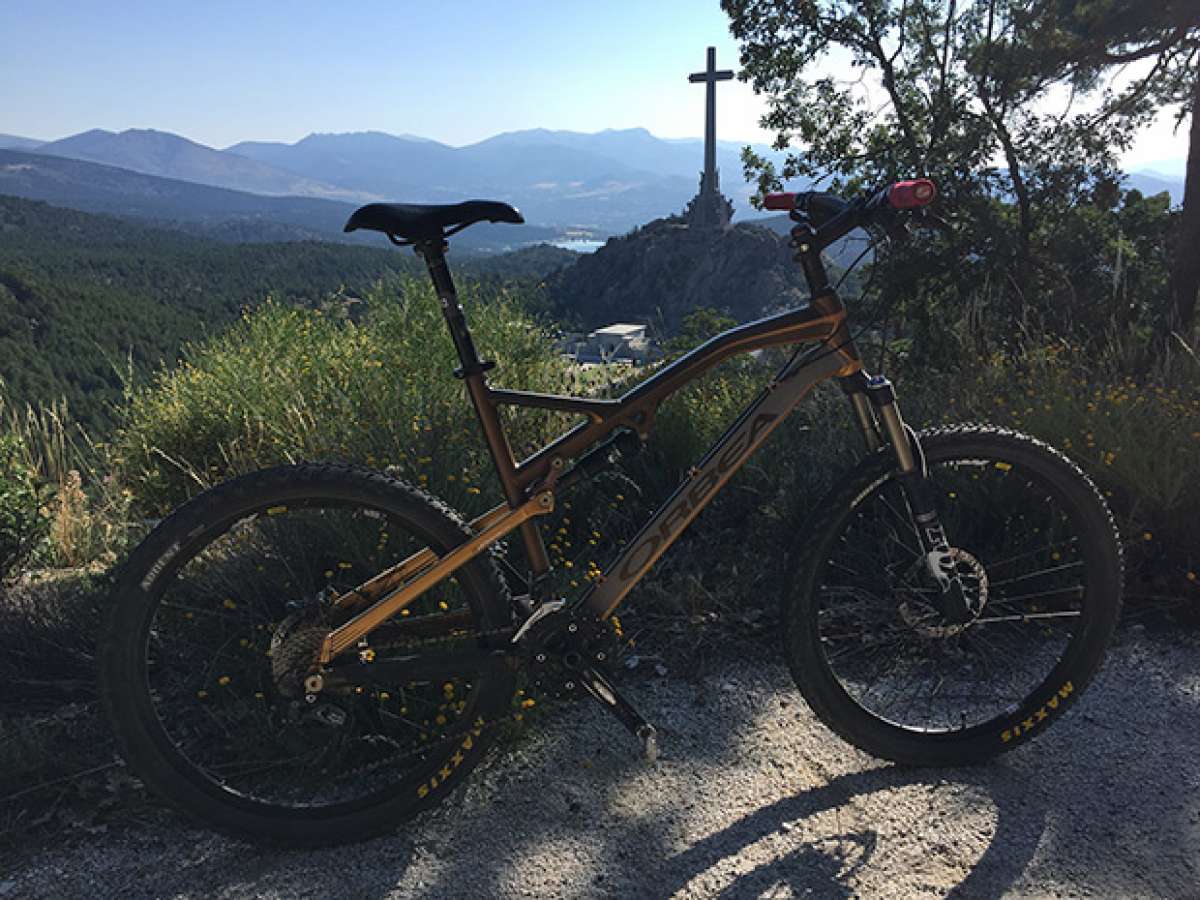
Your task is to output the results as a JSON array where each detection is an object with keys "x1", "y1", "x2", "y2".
[{"x1": 114, "y1": 278, "x2": 574, "y2": 514}]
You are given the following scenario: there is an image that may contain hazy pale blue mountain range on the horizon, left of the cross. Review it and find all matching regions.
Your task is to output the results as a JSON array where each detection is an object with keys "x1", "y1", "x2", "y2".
[{"x1": 0, "y1": 128, "x2": 787, "y2": 234}]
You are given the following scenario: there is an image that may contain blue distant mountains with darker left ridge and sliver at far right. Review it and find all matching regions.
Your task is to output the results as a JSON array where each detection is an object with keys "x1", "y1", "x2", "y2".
[{"x1": 0, "y1": 128, "x2": 1183, "y2": 248}]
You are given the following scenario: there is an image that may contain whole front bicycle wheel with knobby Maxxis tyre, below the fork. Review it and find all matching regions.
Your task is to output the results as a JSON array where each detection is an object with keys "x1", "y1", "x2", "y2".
[{"x1": 782, "y1": 426, "x2": 1122, "y2": 764}]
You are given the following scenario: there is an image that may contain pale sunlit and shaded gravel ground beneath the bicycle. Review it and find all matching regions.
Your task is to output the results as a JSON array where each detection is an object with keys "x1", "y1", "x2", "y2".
[{"x1": 0, "y1": 626, "x2": 1200, "y2": 900}]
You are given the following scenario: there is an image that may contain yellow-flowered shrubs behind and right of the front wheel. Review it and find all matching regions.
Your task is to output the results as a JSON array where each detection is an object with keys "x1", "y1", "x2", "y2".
[{"x1": 901, "y1": 343, "x2": 1200, "y2": 607}]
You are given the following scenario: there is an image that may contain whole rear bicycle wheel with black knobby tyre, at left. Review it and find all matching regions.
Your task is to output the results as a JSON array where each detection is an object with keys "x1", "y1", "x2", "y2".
[{"x1": 101, "y1": 466, "x2": 515, "y2": 845}]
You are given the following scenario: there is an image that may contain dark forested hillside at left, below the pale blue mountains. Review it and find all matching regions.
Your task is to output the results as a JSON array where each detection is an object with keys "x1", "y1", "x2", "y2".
[{"x1": 0, "y1": 196, "x2": 575, "y2": 425}]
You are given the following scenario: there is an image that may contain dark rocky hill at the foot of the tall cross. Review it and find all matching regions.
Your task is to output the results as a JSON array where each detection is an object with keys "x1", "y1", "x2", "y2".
[{"x1": 547, "y1": 216, "x2": 808, "y2": 334}]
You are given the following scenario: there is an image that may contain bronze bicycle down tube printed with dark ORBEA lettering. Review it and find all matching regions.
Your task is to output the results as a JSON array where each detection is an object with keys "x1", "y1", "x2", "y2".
[{"x1": 581, "y1": 347, "x2": 846, "y2": 618}]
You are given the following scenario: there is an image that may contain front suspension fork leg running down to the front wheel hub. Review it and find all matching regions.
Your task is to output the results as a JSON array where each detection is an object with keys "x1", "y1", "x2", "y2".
[{"x1": 864, "y1": 374, "x2": 976, "y2": 623}]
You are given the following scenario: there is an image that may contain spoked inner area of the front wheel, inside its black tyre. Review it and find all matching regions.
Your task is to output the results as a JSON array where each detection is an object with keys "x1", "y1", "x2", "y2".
[{"x1": 817, "y1": 451, "x2": 1086, "y2": 732}]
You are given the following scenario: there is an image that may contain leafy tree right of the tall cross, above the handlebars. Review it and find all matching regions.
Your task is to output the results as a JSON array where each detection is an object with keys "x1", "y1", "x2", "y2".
[{"x1": 722, "y1": 0, "x2": 1185, "y2": 360}]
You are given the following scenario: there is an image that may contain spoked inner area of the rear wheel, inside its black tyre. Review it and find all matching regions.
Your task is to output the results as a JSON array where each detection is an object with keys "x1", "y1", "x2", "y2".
[{"x1": 146, "y1": 496, "x2": 501, "y2": 806}]
